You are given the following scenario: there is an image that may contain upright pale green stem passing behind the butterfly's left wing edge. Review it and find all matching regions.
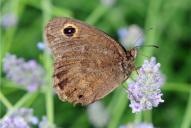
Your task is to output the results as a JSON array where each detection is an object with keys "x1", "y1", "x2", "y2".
[{"x1": 41, "y1": 0, "x2": 54, "y2": 124}]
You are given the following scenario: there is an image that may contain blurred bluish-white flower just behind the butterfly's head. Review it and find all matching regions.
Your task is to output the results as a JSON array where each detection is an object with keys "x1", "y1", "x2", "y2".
[{"x1": 117, "y1": 25, "x2": 144, "y2": 49}]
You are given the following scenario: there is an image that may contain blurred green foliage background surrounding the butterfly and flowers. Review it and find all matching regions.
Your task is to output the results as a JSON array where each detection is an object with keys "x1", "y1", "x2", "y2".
[{"x1": 0, "y1": 0, "x2": 191, "y2": 128}]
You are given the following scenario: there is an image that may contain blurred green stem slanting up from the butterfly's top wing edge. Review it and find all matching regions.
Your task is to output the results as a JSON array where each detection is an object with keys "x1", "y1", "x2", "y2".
[{"x1": 86, "y1": 4, "x2": 109, "y2": 24}]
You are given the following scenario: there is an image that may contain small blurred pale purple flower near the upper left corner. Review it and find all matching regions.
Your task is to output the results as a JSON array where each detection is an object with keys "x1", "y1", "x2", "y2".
[{"x1": 1, "y1": 13, "x2": 17, "y2": 28}]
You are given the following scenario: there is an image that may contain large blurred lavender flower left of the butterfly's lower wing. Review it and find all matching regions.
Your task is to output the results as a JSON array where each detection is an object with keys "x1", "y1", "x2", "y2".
[{"x1": 3, "y1": 54, "x2": 45, "y2": 92}]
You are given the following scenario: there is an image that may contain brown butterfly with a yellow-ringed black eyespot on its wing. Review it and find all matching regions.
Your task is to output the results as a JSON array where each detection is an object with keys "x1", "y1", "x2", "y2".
[{"x1": 45, "y1": 18, "x2": 137, "y2": 105}]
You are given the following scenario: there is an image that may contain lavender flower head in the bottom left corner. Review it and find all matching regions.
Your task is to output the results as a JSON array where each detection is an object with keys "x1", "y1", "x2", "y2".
[{"x1": 0, "y1": 108, "x2": 38, "y2": 128}]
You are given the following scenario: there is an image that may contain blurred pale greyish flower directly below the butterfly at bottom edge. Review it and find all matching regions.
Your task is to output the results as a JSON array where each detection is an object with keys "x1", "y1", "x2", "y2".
[{"x1": 87, "y1": 101, "x2": 109, "y2": 128}]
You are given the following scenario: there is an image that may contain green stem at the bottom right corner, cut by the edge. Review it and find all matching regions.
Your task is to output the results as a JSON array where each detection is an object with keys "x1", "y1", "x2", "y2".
[{"x1": 181, "y1": 89, "x2": 191, "y2": 128}]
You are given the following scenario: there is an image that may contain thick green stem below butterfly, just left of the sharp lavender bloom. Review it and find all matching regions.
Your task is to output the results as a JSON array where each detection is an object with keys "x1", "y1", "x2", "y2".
[{"x1": 108, "y1": 83, "x2": 128, "y2": 128}]
